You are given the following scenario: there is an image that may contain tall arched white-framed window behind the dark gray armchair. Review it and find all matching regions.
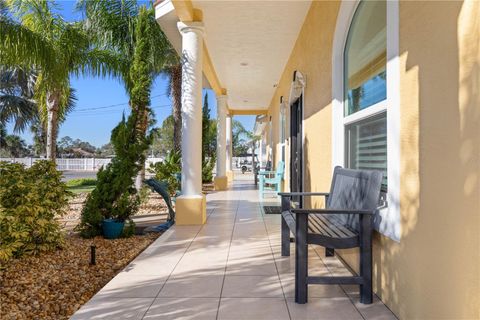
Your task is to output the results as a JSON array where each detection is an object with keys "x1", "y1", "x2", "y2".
[{"x1": 343, "y1": 1, "x2": 388, "y2": 191}]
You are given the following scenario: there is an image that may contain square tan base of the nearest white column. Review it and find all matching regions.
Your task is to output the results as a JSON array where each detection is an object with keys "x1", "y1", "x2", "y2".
[{"x1": 175, "y1": 195, "x2": 207, "y2": 225}]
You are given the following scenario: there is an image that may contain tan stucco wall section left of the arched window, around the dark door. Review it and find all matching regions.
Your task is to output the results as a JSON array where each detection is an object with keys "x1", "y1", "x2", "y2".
[{"x1": 269, "y1": 2, "x2": 338, "y2": 198}]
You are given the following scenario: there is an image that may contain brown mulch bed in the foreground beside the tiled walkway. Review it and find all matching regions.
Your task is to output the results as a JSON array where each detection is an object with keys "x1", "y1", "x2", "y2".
[{"x1": 0, "y1": 233, "x2": 159, "y2": 320}]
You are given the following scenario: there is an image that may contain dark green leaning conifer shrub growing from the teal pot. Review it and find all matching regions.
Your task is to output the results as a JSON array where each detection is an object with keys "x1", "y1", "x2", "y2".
[{"x1": 77, "y1": 113, "x2": 151, "y2": 238}]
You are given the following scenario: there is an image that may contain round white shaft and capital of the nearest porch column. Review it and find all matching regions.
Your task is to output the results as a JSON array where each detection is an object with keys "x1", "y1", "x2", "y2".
[{"x1": 178, "y1": 22, "x2": 204, "y2": 197}]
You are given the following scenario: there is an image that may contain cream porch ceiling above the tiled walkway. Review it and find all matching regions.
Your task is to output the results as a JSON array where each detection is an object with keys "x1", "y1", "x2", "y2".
[{"x1": 157, "y1": 0, "x2": 311, "y2": 111}]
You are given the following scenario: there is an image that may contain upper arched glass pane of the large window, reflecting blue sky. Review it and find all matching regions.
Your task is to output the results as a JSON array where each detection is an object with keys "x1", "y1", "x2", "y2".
[{"x1": 344, "y1": 1, "x2": 387, "y2": 116}]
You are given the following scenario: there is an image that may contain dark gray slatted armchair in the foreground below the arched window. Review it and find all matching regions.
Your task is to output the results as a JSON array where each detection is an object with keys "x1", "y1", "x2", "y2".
[{"x1": 279, "y1": 167, "x2": 382, "y2": 304}]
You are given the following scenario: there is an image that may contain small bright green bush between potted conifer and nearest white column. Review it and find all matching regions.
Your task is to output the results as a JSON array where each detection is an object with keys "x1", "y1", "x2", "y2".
[{"x1": 148, "y1": 150, "x2": 182, "y2": 195}]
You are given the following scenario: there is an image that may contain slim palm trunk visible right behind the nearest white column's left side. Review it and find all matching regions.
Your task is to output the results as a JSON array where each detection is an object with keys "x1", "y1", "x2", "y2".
[{"x1": 169, "y1": 63, "x2": 182, "y2": 152}]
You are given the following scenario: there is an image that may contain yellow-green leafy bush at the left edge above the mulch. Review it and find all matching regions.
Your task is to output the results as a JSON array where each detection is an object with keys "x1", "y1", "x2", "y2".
[{"x1": 0, "y1": 161, "x2": 71, "y2": 261}]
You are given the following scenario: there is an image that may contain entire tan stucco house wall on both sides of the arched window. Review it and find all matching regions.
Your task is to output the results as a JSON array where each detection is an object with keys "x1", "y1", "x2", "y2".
[{"x1": 269, "y1": 1, "x2": 480, "y2": 319}]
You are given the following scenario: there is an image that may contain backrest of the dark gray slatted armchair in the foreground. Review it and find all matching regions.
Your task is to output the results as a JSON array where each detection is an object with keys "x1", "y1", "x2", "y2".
[{"x1": 326, "y1": 167, "x2": 383, "y2": 230}]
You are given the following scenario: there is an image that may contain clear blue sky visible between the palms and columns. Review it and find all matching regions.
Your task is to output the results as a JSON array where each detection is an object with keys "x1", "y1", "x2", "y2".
[{"x1": 7, "y1": 1, "x2": 255, "y2": 147}]
